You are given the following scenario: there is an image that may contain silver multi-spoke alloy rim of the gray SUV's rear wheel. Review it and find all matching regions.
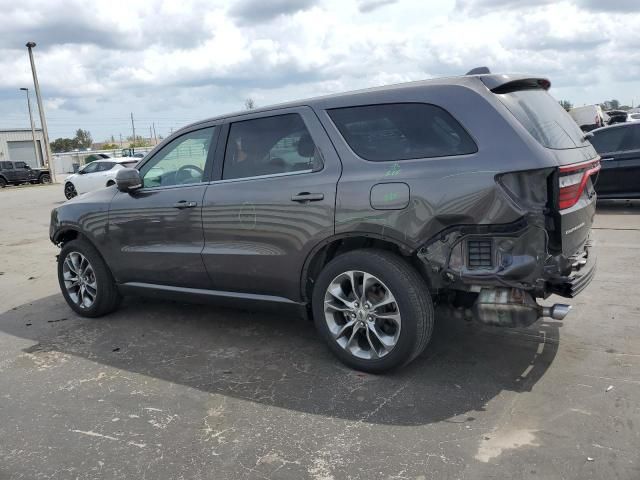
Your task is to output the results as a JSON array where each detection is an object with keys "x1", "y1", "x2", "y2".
[{"x1": 324, "y1": 270, "x2": 402, "y2": 360}]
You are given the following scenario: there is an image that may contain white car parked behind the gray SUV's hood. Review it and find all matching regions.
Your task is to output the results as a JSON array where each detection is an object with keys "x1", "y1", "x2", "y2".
[{"x1": 64, "y1": 157, "x2": 140, "y2": 199}]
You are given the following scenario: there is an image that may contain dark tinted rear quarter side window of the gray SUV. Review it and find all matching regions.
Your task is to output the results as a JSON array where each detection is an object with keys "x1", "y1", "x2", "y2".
[{"x1": 328, "y1": 103, "x2": 478, "y2": 162}]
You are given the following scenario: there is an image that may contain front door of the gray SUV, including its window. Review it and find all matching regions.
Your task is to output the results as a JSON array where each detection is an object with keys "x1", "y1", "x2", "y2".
[{"x1": 108, "y1": 126, "x2": 217, "y2": 288}]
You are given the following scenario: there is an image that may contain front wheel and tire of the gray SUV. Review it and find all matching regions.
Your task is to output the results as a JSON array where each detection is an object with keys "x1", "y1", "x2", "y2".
[{"x1": 58, "y1": 240, "x2": 122, "y2": 317}]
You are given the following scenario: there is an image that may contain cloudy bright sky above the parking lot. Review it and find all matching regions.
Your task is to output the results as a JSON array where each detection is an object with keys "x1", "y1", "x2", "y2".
[{"x1": 0, "y1": 0, "x2": 640, "y2": 141}]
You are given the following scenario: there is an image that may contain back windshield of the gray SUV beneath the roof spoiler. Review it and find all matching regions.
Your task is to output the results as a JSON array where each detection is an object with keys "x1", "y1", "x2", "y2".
[{"x1": 498, "y1": 90, "x2": 585, "y2": 149}]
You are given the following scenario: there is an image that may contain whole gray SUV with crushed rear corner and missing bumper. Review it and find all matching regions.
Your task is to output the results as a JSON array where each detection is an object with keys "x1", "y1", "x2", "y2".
[{"x1": 50, "y1": 74, "x2": 600, "y2": 372}]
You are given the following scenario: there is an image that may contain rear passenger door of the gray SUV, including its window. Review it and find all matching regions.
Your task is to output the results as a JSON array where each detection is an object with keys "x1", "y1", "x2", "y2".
[{"x1": 203, "y1": 107, "x2": 341, "y2": 301}]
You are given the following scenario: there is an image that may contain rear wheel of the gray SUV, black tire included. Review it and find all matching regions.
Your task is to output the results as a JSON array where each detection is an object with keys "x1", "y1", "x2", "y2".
[{"x1": 312, "y1": 249, "x2": 434, "y2": 373}]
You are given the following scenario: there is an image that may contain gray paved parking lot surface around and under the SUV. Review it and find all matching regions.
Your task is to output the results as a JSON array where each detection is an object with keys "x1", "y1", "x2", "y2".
[{"x1": 0, "y1": 185, "x2": 640, "y2": 480}]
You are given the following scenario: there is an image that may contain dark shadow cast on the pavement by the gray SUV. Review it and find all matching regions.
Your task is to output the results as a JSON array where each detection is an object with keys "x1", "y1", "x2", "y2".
[{"x1": 0, "y1": 295, "x2": 560, "y2": 425}]
